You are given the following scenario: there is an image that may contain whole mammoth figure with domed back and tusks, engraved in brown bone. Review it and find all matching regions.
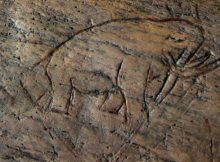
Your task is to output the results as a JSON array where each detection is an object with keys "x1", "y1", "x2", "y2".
[{"x1": 22, "y1": 18, "x2": 219, "y2": 121}]
